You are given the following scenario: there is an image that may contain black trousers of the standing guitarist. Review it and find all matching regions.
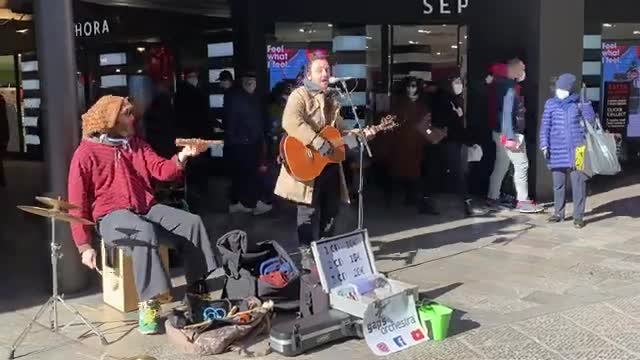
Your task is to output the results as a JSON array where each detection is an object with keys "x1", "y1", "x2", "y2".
[{"x1": 298, "y1": 164, "x2": 340, "y2": 246}]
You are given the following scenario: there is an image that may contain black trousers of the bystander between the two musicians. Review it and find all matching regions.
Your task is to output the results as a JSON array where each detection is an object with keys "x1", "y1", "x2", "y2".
[{"x1": 224, "y1": 144, "x2": 261, "y2": 209}]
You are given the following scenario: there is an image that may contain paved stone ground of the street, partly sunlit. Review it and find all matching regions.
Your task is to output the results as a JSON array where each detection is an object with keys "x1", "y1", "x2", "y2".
[{"x1": 0, "y1": 162, "x2": 640, "y2": 360}]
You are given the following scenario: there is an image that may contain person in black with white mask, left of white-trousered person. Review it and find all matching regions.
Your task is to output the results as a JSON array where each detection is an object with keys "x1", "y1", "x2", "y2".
[{"x1": 429, "y1": 77, "x2": 487, "y2": 216}]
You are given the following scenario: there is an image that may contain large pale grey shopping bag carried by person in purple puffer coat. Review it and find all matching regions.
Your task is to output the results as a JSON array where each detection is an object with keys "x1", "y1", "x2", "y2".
[{"x1": 582, "y1": 119, "x2": 621, "y2": 176}]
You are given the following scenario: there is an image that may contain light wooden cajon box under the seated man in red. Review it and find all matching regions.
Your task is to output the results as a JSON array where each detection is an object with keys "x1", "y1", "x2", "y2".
[{"x1": 101, "y1": 241, "x2": 171, "y2": 313}]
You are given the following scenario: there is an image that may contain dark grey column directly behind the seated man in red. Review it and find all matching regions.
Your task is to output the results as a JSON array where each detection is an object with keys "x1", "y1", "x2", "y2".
[{"x1": 34, "y1": 0, "x2": 88, "y2": 293}]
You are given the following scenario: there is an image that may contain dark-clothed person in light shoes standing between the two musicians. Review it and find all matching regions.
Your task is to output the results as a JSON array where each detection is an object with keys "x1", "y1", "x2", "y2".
[{"x1": 223, "y1": 72, "x2": 272, "y2": 215}]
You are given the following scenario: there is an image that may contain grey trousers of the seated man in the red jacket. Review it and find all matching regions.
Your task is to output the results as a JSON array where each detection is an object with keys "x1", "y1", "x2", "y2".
[{"x1": 98, "y1": 205, "x2": 217, "y2": 301}]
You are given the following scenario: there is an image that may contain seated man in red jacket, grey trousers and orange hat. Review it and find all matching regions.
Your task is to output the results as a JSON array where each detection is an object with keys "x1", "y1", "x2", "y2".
[{"x1": 68, "y1": 96, "x2": 217, "y2": 334}]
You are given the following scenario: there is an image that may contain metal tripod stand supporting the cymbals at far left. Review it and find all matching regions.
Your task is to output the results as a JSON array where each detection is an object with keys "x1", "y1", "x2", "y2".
[{"x1": 9, "y1": 217, "x2": 108, "y2": 360}]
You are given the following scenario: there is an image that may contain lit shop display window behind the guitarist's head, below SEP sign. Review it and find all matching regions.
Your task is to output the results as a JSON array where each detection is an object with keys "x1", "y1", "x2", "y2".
[{"x1": 267, "y1": 22, "x2": 467, "y2": 124}]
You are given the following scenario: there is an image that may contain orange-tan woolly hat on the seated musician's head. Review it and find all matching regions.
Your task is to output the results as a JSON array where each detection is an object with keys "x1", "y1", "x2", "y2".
[{"x1": 82, "y1": 95, "x2": 124, "y2": 137}]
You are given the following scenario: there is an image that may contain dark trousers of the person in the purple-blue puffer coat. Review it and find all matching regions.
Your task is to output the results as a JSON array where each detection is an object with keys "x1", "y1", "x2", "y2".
[{"x1": 551, "y1": 169, "x2": 588, "y2": 220}]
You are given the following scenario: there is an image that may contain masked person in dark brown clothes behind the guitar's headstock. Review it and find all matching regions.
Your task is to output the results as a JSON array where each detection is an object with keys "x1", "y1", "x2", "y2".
[{"x1": 378, "y1": 77, "x2": 430, "y2": 206}]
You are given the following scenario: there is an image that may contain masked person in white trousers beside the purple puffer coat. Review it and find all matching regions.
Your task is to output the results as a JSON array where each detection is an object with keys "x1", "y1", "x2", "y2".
[{"x1": 487, "y1": 59, "x2": 544, "y2": 213}]
